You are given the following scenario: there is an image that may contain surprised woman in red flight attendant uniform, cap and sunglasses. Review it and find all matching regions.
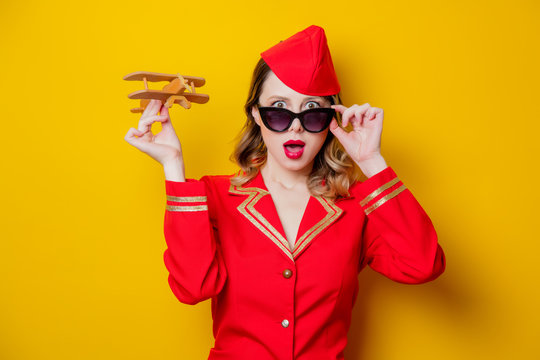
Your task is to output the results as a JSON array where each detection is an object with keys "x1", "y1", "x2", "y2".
[{"x1": 126, "y1": 26, "x2": 445, "y2": 360}]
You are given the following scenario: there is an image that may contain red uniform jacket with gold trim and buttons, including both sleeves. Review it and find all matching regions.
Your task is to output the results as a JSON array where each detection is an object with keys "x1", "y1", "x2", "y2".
[{"x1": 164, "y1": 167, "x2": 446, "y2": 360}]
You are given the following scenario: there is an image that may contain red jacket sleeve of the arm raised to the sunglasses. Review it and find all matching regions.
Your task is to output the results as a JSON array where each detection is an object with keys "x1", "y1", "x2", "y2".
[{"x1": 358, "y1": 167, "x2": 446, "y2": 284}]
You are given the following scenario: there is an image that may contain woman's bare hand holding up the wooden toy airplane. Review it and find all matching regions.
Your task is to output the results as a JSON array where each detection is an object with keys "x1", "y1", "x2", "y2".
[{"x1": 124, "y1": 100, "x2": 183, "y2": 166}]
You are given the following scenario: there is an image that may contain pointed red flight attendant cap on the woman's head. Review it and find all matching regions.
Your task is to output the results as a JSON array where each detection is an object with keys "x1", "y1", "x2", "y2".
[{"x1": 261, "y1": 25, "x2": 341, "y2": 96}]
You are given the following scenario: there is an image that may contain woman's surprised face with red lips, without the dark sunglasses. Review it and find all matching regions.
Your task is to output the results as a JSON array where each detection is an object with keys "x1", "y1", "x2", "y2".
[{"x1": 251, "y1": 72, "x2": 330, "y2": 171}]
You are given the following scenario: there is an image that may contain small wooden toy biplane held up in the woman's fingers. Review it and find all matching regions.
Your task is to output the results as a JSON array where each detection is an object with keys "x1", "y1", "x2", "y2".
[{"x1": 123, "y1": 71, "x2": 210, "y2": 113}]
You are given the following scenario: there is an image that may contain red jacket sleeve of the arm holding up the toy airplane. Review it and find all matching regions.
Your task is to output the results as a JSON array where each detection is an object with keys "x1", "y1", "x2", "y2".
[{"x1": 163, "y1": 176, "x2": 227, "y2": 305}]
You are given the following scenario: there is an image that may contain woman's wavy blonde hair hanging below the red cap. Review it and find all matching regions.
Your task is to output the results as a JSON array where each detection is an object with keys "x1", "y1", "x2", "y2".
[{"x1": 230, "y1": 58, "x2": 361, "y2": 201}]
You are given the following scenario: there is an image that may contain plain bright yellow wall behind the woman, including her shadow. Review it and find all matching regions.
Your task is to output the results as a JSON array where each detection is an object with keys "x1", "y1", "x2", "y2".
[{"x1": 0, "y1": 0, "x2": 540, "y2": 360}]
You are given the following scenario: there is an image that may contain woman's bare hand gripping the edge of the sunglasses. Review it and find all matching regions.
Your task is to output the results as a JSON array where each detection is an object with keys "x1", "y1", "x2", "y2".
[{"x1": 330, "y1": 103, "x2": 387, "y2": 177}]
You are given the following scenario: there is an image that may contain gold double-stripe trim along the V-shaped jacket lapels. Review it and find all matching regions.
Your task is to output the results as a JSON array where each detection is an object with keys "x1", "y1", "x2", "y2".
[{"x1": 229, "y1": 184, "x2": 343, "y2": 261}]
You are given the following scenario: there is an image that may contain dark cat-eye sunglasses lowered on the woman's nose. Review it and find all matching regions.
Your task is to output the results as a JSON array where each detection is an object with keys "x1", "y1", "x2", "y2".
[{"x1": 258, "y1": 106, "x2": 336, "y2": 133}]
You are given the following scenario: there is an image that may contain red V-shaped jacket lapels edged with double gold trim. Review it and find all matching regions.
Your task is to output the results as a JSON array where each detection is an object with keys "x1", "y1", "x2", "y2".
[{"x1": 229, "y1": 171, "x2": 343, "y2": 261}]
